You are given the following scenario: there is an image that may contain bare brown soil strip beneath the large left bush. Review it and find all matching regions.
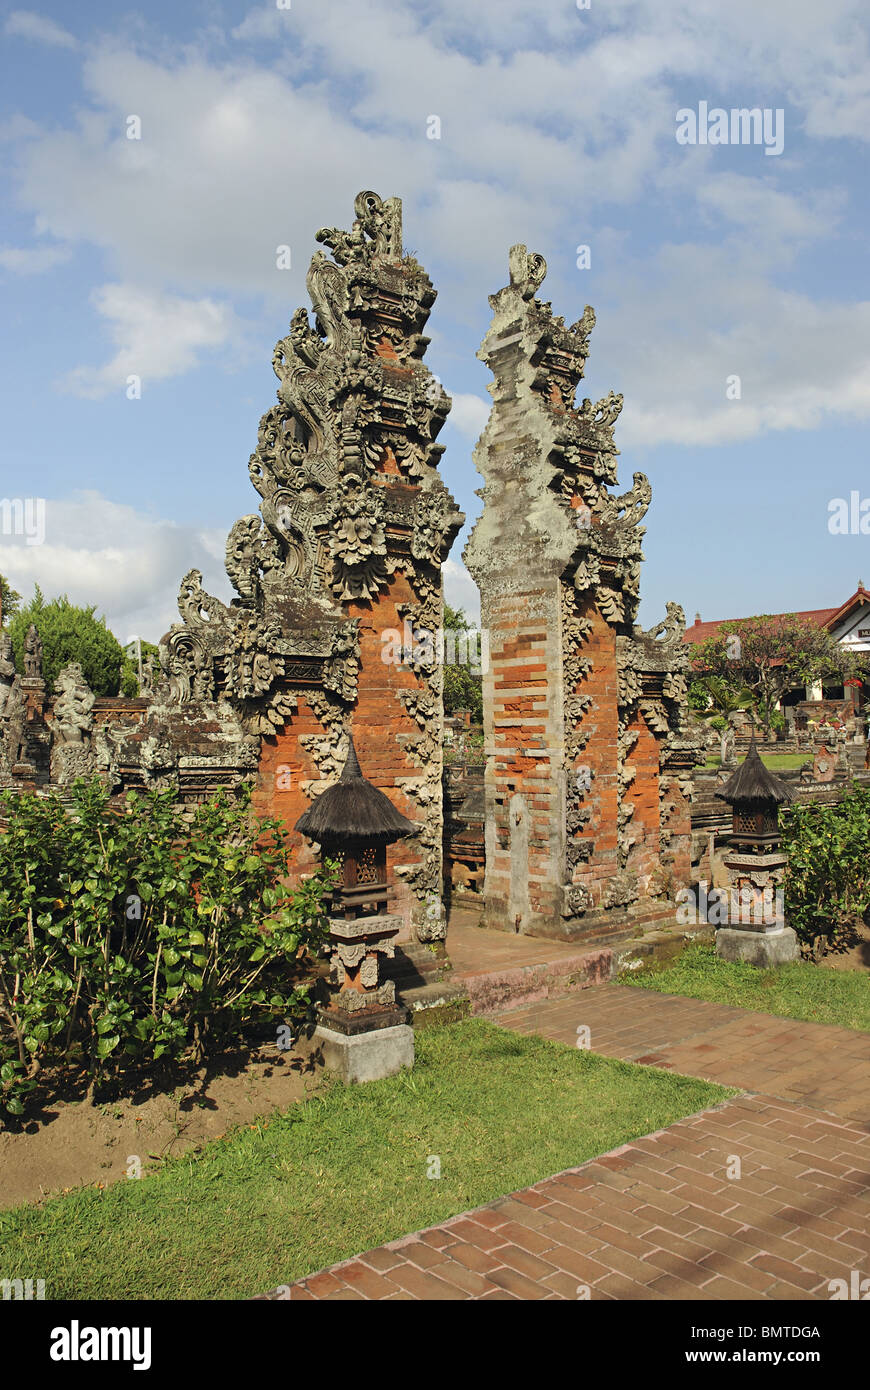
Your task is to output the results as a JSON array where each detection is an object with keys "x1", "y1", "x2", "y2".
[{"x1": 0, "y1": 1034, "x2": 322, "y2": 1207}]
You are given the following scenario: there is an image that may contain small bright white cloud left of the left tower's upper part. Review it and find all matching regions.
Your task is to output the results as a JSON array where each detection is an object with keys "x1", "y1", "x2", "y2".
[{"x1": 61, "y1": 285, "x2": 233, "y2": 398}]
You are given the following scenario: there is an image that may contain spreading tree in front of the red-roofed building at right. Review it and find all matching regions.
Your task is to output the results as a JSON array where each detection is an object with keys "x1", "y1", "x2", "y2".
[{"x1": 692, "y1": 613, "x2": 862, "y2": 733}]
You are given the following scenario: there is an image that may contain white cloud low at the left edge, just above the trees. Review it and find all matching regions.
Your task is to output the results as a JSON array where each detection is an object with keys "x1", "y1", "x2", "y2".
[{"x1": 0, "y1": 492, "x2": 235, "y2": 642}]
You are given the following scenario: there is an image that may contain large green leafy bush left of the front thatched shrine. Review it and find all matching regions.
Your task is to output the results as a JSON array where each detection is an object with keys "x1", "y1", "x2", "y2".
[{"x1": 0, "y1": 781, "x2": 332, "y2": 1115}]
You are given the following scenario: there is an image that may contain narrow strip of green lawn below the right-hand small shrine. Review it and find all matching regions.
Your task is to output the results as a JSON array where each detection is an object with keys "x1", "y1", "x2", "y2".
[{"x1": 620, "y1": 945, "x2": 870, "y2": 1030}]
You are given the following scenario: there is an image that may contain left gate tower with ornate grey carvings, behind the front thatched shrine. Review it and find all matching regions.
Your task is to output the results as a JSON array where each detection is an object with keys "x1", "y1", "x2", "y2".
[{"x1": 99, "y1": 192, "x2": 464, "y2": 940}]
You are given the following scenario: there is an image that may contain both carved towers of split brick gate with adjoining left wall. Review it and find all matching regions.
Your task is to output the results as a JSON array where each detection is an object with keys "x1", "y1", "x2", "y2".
[{"x1": 0, "y1": 192, "x2": 695, "y2": 941}]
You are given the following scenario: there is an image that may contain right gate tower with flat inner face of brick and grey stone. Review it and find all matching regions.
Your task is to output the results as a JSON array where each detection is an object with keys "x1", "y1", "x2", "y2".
[{"x1": 464, "y1": 246, "x2": 696, "y2": 937}]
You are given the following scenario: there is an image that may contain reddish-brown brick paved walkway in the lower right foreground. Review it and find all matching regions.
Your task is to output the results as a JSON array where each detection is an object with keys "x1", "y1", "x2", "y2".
[{"x1": 265, "y1": 986, "x2": 870, "y2": 1300}]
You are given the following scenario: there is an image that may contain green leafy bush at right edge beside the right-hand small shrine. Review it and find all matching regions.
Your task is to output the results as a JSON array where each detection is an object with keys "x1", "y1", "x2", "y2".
[{"x1": 782, "y1": 783, "x2": 870, "y2": 944}]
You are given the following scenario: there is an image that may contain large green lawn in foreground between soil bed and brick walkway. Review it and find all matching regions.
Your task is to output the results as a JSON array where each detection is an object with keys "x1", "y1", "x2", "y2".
[{"x1": 0, "y1": 1005, "x2": 734, "y2": 1300}]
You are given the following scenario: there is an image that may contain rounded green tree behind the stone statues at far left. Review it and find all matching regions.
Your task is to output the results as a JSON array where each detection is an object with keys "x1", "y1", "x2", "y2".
[{"x1": 10, "y1": 585, "x2": 124, "y2": 695}]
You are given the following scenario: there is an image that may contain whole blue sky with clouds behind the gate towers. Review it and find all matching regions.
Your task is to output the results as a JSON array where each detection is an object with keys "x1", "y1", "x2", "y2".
[{"x1": 0, "y1": 0, "x2": 870, "y2": 641}]
